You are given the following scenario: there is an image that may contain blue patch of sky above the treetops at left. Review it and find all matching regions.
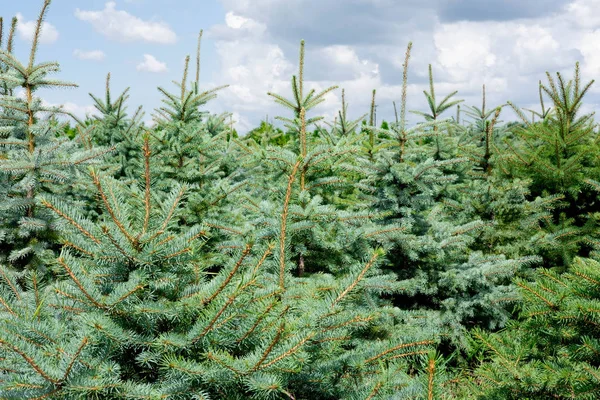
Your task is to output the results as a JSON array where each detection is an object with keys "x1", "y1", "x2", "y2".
[{"x1": 1, "y1": 0, "x2": 224, "y2": 125}]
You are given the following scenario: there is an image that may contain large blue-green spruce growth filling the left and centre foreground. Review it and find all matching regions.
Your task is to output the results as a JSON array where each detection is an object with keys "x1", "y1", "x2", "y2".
[{"x1": 0, "y1": 136, "x2": 444, "y2": 399}]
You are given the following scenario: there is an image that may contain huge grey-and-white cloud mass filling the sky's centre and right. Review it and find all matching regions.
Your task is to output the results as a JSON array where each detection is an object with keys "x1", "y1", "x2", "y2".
[{"x1": 208, "y1": 0, "x2": 600, "y2": 133}]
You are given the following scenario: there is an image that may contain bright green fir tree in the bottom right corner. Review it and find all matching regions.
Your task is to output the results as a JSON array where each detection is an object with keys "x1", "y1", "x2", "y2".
[{"x1": 466, "y1": 258, "x2": 600, "y2": 400}]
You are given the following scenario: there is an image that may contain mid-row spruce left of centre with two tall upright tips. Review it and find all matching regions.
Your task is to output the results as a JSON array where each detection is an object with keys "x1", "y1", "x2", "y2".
[{"x1": 152, "y1": 37, "x2": 251, "y2": 233}]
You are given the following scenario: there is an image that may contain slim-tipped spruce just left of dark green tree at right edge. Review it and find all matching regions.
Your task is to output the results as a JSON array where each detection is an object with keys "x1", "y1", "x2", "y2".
[{"x1": 442, "y1": 85, "x2": 560, "y2": 258}]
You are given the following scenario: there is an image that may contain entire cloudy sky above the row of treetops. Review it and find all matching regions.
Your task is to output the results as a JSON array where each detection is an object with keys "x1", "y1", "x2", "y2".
[{"x1": 1, "y1": 0, "x2": 600, "y2": 133}]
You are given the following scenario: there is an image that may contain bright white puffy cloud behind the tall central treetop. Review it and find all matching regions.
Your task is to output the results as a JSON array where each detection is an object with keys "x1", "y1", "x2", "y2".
[{"x1": 210, "y1": 13, "x2": 381, "y2": 133}]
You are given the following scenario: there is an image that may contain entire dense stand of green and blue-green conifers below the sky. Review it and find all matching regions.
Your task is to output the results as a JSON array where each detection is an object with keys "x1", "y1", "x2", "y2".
[{"x1": 0, "y1": 0, "x2": 600, "y2": 400}]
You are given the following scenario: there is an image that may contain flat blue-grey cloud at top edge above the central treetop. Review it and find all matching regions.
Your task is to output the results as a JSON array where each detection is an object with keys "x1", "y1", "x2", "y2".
[{"x1": 216, "y1": 0, "x2": 437, "y2": 50}]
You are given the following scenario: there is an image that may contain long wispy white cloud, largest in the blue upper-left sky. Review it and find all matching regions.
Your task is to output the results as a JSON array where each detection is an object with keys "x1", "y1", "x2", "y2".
[{"x1": 75, "y1": 1, "x2": 177, "y2": 44}]
